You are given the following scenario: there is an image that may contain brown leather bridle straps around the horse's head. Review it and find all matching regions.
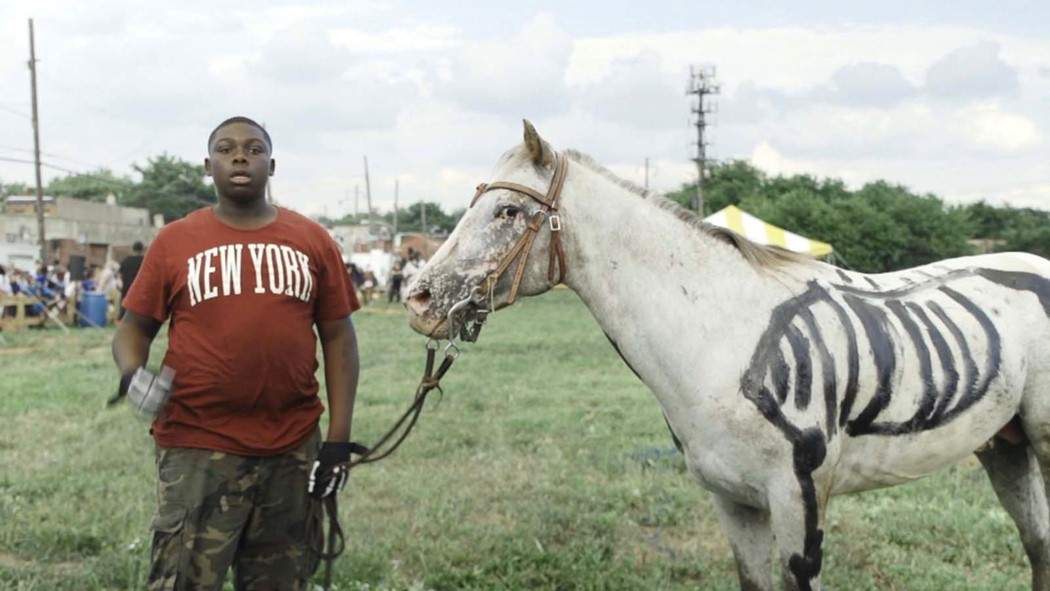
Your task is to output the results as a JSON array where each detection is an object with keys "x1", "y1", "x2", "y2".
[{"x1": 470, "y1": 152, "x2": 569, "y2": 305}]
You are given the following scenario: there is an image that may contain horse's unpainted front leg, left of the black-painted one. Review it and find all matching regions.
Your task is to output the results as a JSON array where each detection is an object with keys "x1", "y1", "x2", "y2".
[{"x1": 711, "y1": 493, "x2": 773, "y2": 591}]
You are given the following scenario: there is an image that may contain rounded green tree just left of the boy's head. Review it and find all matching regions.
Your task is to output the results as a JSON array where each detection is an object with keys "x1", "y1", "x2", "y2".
[{"x1": 128, "y1": 153, "x2": 215, "y2": 221}]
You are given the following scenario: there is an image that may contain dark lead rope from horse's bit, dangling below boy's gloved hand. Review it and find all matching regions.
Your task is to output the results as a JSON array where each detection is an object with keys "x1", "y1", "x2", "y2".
[{"x1": 307, "y1": 340, "x2": 464, "y2": 591}]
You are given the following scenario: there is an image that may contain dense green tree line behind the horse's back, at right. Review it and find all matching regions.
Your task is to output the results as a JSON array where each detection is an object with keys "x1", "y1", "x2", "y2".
[{"x1": 668, "y1": 160, "x2": 1050, "y2": 273}]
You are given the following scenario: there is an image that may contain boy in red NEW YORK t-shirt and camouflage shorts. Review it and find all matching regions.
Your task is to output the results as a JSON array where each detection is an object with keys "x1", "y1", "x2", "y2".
[{"x1": 113, "y1": 117, "x2": 360, "y2": 590}]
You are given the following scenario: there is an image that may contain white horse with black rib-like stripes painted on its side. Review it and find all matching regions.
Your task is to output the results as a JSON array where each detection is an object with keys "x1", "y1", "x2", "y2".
[{"x1": 405, "y1": 121, "x2": 1050, "y2": 591}]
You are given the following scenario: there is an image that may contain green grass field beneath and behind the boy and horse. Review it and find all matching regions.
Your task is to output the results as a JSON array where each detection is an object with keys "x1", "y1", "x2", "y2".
[{"x1": 0, "y1": 291, "x2": 1029, "y2": 591}]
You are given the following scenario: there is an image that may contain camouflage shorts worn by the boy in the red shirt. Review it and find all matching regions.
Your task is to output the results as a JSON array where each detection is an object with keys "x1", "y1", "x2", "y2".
[{"x1": 149, "y1": 432, "x2": 321, "y2": 591}]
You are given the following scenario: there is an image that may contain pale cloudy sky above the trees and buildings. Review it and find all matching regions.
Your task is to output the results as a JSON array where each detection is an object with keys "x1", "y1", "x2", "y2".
[{"x1": 0, "y1": 0, "x2": 1050, "y2": 217}]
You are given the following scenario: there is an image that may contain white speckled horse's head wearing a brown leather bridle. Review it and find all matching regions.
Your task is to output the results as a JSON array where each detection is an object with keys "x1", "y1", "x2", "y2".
[{"x1": 405, "y1": 121, "x2": 568, "y2": 338}]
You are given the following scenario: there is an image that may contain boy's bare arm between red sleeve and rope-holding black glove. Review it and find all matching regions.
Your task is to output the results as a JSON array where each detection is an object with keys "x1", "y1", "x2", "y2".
[{"x1": 317, "y1": 316, "x2": 360, "y2": 443}]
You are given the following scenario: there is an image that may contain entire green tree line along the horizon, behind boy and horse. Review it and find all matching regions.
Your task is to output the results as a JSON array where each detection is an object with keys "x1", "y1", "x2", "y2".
[{"x1": 0, "y1": 154, "x2": 1050, "y2": 273}]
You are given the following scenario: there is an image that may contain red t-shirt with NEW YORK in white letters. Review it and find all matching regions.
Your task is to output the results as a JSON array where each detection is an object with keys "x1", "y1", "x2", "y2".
[{"x1": 124, "y1": 208, "x2": 360, "y2": 456}]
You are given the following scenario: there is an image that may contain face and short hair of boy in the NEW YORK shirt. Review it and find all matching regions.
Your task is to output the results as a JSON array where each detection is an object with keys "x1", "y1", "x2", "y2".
[{"x1": 204, "y1": 123, "x2": 275, "y2": 203}]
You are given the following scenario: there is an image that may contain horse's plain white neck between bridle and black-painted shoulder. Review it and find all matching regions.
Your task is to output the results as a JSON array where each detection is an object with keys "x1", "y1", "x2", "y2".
[{"x1": 562, "y1": 171, "x2": 802, "y2": 398}]
